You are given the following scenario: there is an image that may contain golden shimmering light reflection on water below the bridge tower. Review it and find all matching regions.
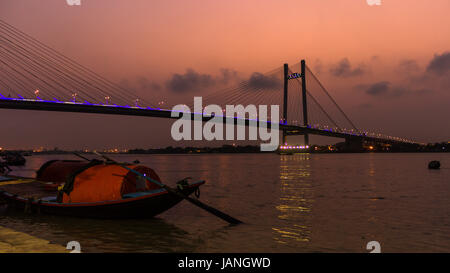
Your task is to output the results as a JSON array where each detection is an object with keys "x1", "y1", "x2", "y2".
[{"x1": 272, "y1": 154, "x2": 314, "y2": 244}]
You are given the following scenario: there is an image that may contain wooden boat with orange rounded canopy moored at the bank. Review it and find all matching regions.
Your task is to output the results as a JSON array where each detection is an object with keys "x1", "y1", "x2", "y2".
[{"x1": 0, "y1": 160, "x2": 205, "y2": 218}]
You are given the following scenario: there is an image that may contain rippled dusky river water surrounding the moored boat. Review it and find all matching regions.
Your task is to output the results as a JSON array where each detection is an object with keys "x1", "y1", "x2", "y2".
[{"x1": 0, "y1": 153, "x2": 450, "y2": 252}]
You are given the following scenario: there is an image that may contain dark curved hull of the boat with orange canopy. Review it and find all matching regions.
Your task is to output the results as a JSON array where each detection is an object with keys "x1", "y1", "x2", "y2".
[{"x1": 0, "y1": 182, "x2": 204, "y2": 219}]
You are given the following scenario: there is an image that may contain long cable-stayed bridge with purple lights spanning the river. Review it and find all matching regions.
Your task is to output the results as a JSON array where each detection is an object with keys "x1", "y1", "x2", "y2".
[{"x1": 0, "y1": 20, "x2": 419, "y2": 149}]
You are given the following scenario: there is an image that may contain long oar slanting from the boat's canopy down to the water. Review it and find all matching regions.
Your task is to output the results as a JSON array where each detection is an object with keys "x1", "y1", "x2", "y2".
[{"x1": 83, "y1": 151, "x2": 242, "y2": 224}]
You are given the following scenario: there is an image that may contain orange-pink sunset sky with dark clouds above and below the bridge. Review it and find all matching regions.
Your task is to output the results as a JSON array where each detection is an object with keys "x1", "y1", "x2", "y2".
[{"x1": 0, "y1": 0, "x2": 450, "y2": 149}]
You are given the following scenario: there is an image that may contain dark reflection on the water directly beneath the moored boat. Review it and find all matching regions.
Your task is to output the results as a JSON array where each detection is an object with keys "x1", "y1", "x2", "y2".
[{"x1": 0, "y1": 209, "x2": 197, "y2": 252}]
